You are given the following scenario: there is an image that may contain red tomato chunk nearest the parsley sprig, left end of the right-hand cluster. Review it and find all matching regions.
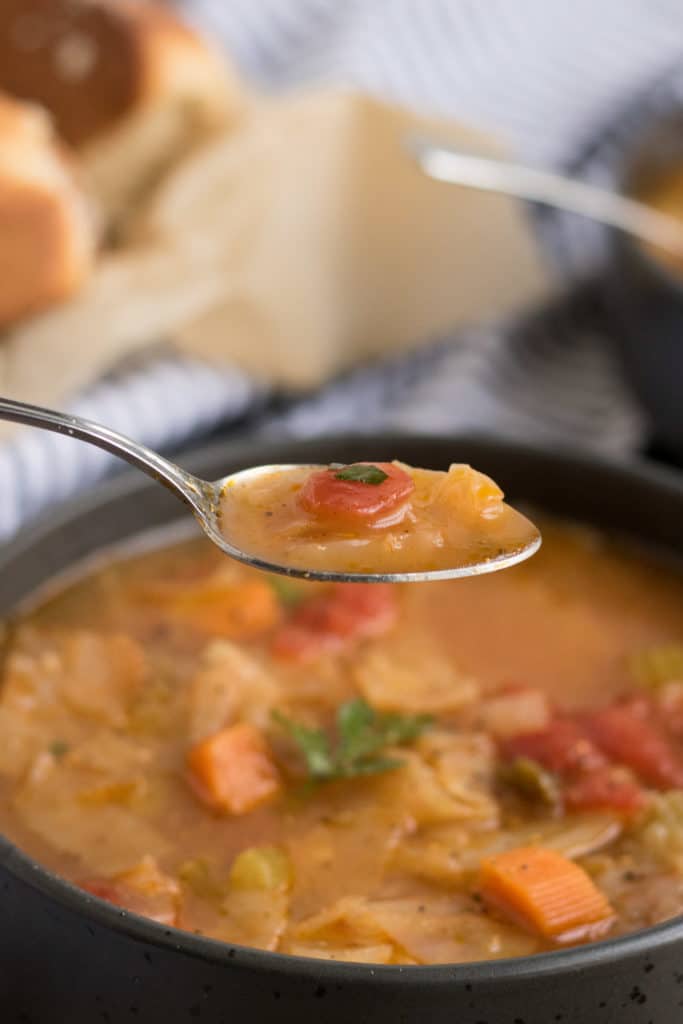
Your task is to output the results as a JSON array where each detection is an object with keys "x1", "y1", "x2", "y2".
[{"x1": 501, "y1": 718, "x2": 607, "y2": 776}]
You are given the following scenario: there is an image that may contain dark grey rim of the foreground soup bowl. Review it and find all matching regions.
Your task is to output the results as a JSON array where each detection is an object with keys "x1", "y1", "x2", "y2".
[{"x1": 0, "y1": 431, "x2": 683, "y2": 987}]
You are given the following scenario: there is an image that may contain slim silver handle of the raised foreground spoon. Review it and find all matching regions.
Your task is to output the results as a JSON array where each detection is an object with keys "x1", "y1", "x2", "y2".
[{"x1": 0, "y1": 396, "x2": 209, "y2": 511}]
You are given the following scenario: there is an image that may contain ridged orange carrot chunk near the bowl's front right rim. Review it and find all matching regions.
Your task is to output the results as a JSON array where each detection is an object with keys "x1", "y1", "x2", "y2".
[{"x1": 480, "y1": 846, "x2": 614, "y2": 944}]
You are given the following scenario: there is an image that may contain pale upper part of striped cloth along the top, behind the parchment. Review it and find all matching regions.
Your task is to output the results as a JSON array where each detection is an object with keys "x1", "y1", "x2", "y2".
[{"x1": 184, "y1": 0, "x2": 683, "y2": 164}]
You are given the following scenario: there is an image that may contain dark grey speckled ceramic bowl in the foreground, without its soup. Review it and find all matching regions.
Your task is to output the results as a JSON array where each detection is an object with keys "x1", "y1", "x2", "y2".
[{"x1": 0, "y1": 436, "x2": 683, "y2": 1024}]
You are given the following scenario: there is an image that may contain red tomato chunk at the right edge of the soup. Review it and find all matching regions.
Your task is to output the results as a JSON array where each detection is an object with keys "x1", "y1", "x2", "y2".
[{"x1": 585, "y1": 700, "x2": 683, "y2": 790}]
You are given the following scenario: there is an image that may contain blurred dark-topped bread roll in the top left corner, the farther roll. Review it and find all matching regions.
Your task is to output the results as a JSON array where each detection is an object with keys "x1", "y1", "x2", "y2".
[{"x1": 0, "y1": 0, "x2": 242, "y2": 224}]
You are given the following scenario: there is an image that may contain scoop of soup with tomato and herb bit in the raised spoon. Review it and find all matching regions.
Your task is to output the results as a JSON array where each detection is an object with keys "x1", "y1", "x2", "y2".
[{"x1": 220, "y1": 462, "x2": 540, "y2": 574}]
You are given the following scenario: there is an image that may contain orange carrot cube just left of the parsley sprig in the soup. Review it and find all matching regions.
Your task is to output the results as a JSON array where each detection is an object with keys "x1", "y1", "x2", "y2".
[{"x1": 187, "y1": 722, "x2": 280, "y2": 814}]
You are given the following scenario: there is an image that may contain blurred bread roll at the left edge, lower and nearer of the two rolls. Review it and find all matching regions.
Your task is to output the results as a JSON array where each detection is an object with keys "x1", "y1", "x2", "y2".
[{"x1": 0, "y1": 95, "x2": 95, "y2": 328}]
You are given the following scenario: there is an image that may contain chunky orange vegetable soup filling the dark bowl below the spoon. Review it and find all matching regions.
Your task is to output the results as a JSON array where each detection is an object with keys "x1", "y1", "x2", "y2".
[{"x1": 0, "y1": 522, "x2": 683, "y2": 964}]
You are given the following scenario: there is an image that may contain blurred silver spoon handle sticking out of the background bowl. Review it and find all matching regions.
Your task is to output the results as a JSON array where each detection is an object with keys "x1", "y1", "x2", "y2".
[{"x1": 407, "y1": 136, "x2": 683, "y2": 257}]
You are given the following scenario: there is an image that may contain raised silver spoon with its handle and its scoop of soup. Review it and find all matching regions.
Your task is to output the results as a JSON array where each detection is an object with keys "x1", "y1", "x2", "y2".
[{"x1": 0, "y1": 398, "x2": 541, "y2": 583}]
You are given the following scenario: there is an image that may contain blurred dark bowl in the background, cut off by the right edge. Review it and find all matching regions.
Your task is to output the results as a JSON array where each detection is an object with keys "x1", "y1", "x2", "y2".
[{"x1": 608, "y1": 110, "x2": 683, "y2": 460}]
